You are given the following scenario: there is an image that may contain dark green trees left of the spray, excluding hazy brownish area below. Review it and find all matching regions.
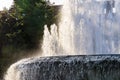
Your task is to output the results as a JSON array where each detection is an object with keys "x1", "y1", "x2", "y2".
[{"x1": 0, "y1": 0, "x2": 57, "y2": 49}]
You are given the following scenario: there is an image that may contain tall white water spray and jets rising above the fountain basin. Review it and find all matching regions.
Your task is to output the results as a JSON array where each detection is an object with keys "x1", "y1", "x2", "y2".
[{"x1": 42, "y1": 0, "x2": 120, "y2": 56}]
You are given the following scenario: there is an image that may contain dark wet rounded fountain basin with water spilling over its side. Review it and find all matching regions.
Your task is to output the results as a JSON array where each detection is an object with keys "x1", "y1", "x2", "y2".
[{"x1": 6, "y1": 54, "x2": 120, "y2": 80}]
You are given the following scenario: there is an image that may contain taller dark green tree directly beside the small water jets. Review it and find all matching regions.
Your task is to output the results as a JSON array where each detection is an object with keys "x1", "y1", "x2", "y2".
[{"x1": 15, "y1": 0, "x2": 57, "y2": 48}]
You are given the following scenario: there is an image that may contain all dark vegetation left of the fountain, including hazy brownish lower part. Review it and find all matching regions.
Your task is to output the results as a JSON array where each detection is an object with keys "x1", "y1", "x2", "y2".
[{"x1": 0, "y1": 0, "x2": 59, "y2": 77}]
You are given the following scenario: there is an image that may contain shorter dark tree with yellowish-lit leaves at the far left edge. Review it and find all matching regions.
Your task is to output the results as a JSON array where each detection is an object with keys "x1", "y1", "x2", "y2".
[{"x1": 0, "y1": 9, "x2": 23, "y2": 46}]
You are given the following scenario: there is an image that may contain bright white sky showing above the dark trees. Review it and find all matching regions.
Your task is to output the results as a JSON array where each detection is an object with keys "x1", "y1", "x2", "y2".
[{"x1": 0, "y1": 0, "x2": 63, "y2": 11}]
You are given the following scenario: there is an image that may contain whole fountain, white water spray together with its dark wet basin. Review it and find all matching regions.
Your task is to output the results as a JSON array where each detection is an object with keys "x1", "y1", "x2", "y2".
[{"x1": 5, "y1": 0, "x2": 120, "y2": 80}]
